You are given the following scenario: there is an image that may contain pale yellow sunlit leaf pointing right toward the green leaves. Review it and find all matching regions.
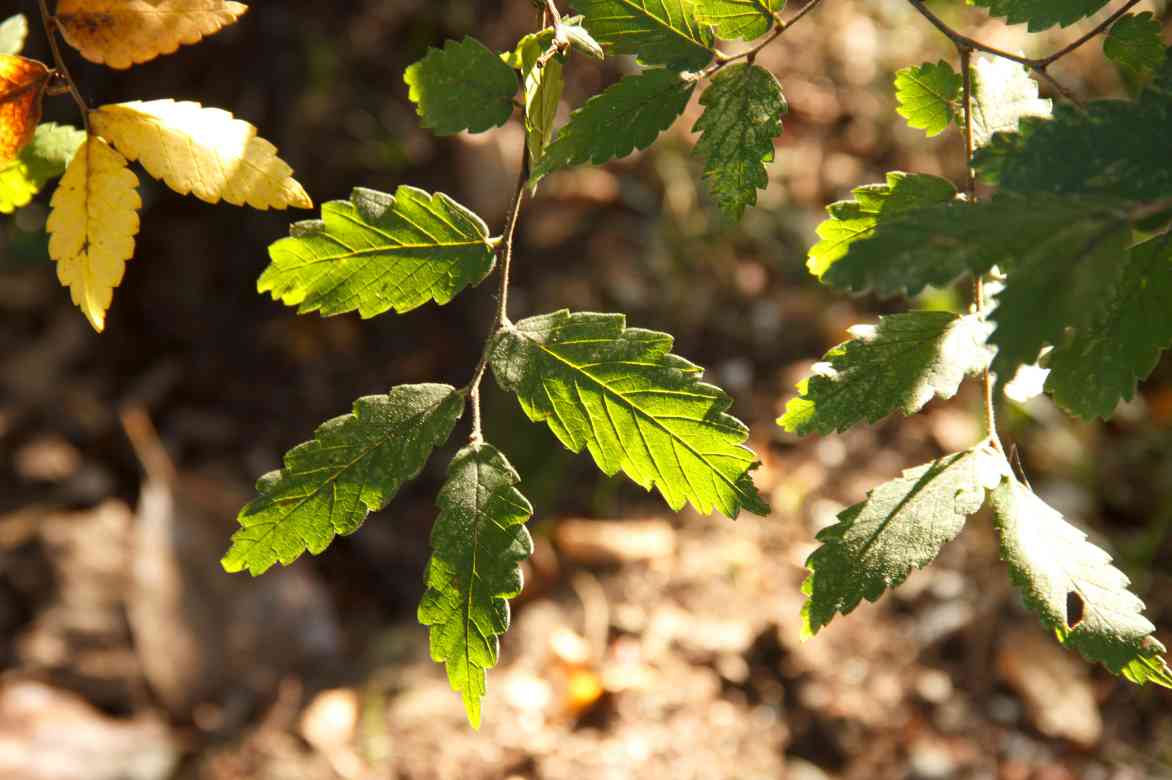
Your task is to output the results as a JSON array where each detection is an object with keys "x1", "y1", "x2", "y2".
[{"x1": 89, "y1": 100, "x2": 313, "y2": 210}]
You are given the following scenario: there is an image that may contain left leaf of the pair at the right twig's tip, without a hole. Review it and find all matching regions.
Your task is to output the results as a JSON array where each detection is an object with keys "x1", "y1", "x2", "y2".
[{"x1": 802, "y1": 446, "x2": 1009, "y2": 638}]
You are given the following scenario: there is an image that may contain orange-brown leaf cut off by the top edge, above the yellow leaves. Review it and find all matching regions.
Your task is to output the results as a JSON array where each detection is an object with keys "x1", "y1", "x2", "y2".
[{"x1": 56, "y1": 0, "x2": 248, "y2": 69}]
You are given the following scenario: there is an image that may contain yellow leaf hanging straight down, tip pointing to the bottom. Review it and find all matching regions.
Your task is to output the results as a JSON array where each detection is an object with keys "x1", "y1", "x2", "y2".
[{"x1": 46, "y1": 136, "x2": 142, "y2": 333}]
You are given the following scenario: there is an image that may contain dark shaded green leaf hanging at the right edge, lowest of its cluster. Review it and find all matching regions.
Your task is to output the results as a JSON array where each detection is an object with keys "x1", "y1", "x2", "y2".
[{"x1": 1045, "y1": 235, "x2": 1172, "y2": 419}]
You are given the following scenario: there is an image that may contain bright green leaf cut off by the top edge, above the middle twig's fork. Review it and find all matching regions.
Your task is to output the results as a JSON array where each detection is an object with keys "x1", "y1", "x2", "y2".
[{"x1": 572, "y1": 0, "x2": 715, "y2": 70}]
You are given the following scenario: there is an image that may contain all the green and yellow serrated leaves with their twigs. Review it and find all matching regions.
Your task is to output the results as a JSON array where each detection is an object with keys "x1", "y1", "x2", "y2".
[{"x1": 0, "y1": 0, "x2": 1172, "y2": 726}]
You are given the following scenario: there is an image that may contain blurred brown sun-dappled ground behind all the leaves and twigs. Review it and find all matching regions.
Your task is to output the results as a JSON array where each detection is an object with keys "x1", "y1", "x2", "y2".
[{"x1": 0, "y1": 0, "x2": 1172, "y2": 780}]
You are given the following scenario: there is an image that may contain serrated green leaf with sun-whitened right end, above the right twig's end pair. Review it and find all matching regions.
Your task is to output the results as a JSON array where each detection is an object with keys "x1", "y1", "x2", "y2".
[{"x1": 777, "y1": 312, "x2": 993, "y2": 436}]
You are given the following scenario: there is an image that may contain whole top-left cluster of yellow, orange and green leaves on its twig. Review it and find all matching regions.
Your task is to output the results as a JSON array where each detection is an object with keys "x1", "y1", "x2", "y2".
[{"x1": 0, "y1": 0, "x2": 313, "y2": 331}]
